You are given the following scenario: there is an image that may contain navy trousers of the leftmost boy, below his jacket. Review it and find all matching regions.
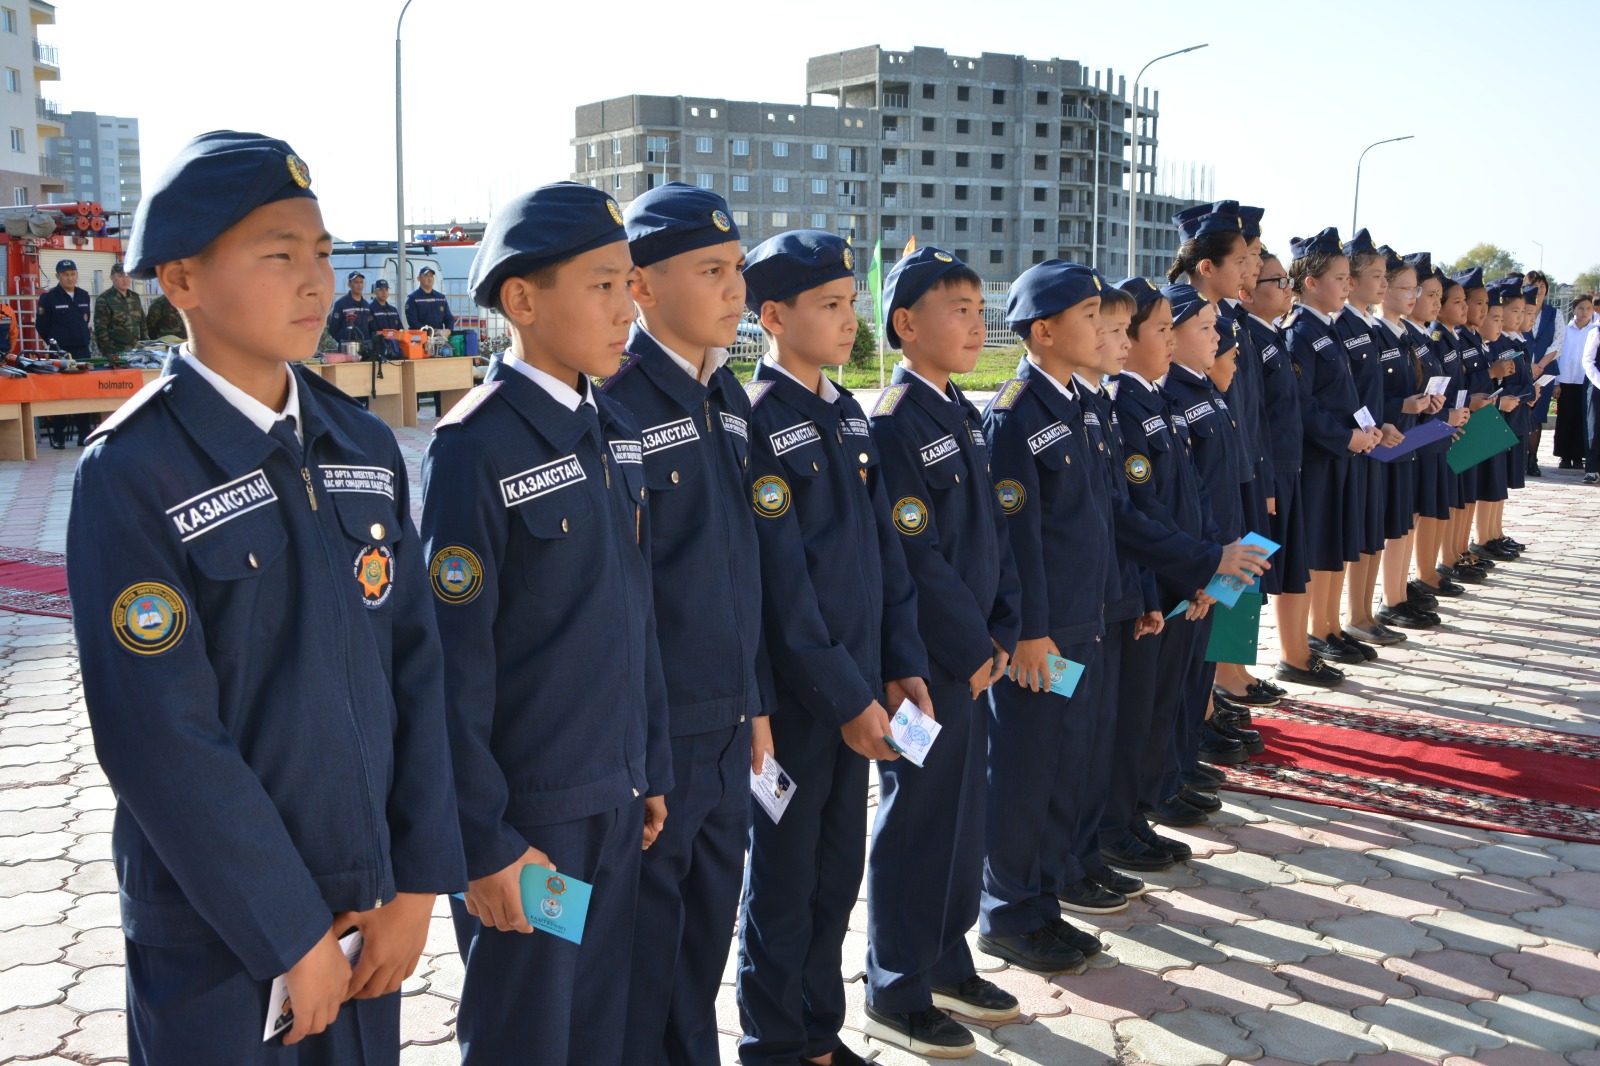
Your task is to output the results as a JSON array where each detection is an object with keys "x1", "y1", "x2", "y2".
[{"x1": 126, "y1": 934, "x2": 400, "y2": 1066}]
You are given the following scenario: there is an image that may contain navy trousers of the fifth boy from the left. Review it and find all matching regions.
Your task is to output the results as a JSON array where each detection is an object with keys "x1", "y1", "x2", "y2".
[{"x1": 867, "y1": 664, "x2": 989, "y2": 1013}]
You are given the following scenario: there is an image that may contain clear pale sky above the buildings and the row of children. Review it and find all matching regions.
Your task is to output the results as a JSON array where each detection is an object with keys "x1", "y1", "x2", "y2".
[{"x1": 56, "y1": 0, "x2": 1600, "y2": 280}]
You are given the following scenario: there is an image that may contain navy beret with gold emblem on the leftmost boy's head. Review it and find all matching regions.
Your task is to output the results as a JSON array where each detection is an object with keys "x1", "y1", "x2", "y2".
[{"x1": 125, "y1": 130, "x2": 317, "y2": 279}]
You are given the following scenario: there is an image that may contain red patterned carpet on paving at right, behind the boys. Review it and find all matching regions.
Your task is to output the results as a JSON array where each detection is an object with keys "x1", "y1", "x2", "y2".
[{"x1": 1227, "y1": 699, "x2": 1600, "y2": 844}]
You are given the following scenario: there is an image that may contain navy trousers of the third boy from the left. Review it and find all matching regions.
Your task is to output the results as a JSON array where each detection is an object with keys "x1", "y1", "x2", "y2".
[{"x1": 622, "y1": 722, "x2": 752, "y2": 1066}]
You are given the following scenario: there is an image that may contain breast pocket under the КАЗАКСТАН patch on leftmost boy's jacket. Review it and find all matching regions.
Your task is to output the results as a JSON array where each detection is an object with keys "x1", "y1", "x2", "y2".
[{"x1": 189, "y1": 509, "x2": 294, "y2": 655}]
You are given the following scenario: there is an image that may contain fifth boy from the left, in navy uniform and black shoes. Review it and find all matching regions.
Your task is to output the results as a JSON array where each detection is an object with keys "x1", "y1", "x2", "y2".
[{"x1": 862, "y1": 248, "x2": 1021, "y2": 1058}]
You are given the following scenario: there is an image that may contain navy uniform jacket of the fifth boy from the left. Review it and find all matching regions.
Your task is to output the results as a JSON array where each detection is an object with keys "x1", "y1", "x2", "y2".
[{"x1": 872, "y1": 367, "x2": 1022, "y2": 679}]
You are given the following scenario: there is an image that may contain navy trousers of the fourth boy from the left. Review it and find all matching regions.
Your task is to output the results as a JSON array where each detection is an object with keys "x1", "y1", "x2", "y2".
[{"x1": 732, "y1": 707, "x2": 864, "y2": 1066}]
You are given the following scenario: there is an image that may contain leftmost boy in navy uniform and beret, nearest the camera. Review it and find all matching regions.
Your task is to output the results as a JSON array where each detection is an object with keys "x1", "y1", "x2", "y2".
[{"x1": 67, "y1": 131, "x2": 466, "y2": 1066}]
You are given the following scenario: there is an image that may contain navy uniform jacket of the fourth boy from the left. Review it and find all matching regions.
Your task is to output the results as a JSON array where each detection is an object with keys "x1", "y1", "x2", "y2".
[{"x1": 746, "y1": 362, "x2": 928, "y2": 728}]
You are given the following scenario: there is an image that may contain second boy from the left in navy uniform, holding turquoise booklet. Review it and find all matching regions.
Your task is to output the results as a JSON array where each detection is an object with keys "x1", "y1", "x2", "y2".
[{"x1": 422, "y1": 181, "x2": 672, "y2": 1066}]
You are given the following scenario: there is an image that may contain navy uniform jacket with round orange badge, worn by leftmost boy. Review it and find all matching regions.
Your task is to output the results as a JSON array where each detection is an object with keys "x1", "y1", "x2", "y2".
[{"x1": 67, "y1": 360, "x2": 466, "y2": 980}]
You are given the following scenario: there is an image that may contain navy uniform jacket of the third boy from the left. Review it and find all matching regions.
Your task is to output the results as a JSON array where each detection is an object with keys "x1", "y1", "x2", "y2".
[{"x1": 602, "y1": 325, "x2": 773, "y2": 736}]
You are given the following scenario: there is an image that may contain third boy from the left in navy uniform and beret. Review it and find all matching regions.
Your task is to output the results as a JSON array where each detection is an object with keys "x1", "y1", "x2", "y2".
[{"x1": 602, "y1": 182, "x2": 773, "y2": 1066}]
